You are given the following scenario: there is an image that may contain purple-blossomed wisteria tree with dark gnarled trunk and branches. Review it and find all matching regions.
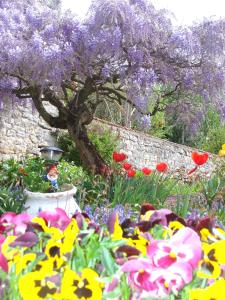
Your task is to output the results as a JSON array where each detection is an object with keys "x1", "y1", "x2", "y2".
[{"x1": 0, "y1": 0, "x2": 224, "y2": 173}]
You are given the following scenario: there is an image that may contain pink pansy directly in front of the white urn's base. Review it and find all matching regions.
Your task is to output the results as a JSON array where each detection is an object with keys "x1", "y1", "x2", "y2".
[{"x1": 39, "y1": 208, "x2": 71, "y2": 230}]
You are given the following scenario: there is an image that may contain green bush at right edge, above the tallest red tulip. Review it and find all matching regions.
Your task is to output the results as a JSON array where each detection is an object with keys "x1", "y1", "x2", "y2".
[{"x1": 194, "y1": 106, "x2": 225, "y2": 154}]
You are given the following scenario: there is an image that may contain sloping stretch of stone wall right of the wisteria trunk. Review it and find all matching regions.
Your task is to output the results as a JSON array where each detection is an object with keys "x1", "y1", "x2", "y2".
[{"x1": 90, "y1": 120, "x2": 215, "y2": 173}]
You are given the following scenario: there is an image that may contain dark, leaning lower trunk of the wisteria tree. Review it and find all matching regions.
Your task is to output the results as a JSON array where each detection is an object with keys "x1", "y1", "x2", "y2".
[{"x1": 68, "y1": 122, "x2": 110, "y2": 176}]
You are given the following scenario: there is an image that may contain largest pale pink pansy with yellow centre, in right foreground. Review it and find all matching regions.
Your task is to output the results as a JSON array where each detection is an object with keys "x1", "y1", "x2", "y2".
[{"x1": 147, "y1": 227, "x2": 202, "y2": 269}]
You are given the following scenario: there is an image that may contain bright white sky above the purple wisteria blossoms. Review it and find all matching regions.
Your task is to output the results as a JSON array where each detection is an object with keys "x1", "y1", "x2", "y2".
[{"x1": 62, "y1": 0, "x2": 225, "y2": 25}]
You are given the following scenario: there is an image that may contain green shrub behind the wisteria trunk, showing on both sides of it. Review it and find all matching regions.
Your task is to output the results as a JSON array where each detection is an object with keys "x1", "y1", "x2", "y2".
[{"x1": 57, "y1": 126, "x2": 118, "y2": 166}]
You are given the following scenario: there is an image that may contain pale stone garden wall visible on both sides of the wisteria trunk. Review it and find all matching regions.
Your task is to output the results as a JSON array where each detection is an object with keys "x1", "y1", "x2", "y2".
[{"x1": 0, "y1": 101, "x2": 213, "y2": 171}]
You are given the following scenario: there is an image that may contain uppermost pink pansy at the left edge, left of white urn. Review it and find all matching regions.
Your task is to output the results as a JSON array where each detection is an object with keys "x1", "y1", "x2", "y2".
[{"x1": 0, "y1": 212, "x2": 31, "y2": 235}]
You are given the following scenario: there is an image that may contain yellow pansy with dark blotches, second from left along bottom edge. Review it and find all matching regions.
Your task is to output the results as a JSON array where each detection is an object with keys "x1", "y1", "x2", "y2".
[{"x1": 61, "y1": 268, "x2": 102, "y2": 300}]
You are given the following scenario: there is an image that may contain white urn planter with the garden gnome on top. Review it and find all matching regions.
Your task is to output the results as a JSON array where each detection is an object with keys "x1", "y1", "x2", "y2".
[{"x1": 24, "y1": 186, "x2": 81, "y2": 217}]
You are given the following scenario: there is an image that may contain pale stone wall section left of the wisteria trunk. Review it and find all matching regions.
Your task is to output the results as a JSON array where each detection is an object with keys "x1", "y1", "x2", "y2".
[{"x1": 0, "y1": 100, "x2": 55, "y2": 160}]
